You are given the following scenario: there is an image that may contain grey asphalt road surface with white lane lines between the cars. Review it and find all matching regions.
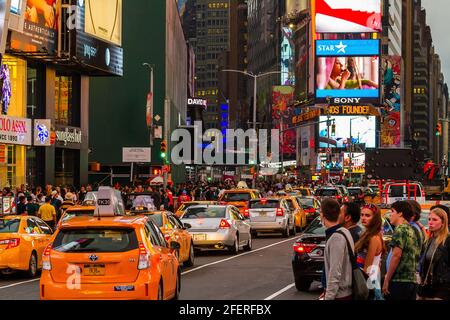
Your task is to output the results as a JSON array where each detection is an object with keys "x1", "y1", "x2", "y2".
[{"x1": 0, "y1": 235, "x2": 321, "y2": 300}]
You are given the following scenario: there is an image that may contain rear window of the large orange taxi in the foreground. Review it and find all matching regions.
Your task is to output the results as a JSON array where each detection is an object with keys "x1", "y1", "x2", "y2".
[{"x1": 53, "y1": 228, "x2": 138, "y2": 253}]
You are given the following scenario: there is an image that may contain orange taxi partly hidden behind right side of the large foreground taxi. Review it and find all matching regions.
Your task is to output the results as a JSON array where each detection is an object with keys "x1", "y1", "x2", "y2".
[{"x1": 131, "y1": 209, "x2": 194, "y2": 267}]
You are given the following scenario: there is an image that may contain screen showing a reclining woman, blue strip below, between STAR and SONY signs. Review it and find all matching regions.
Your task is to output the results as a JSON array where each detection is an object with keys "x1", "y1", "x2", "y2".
[{"x1": 316, "y1": 56, "x2": 380, "y2": 99}]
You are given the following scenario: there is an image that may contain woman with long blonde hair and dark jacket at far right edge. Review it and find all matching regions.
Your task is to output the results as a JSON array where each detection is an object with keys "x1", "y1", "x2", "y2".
[{"x1": 418, "y1": 208, "x2": 450, "y2": 300}]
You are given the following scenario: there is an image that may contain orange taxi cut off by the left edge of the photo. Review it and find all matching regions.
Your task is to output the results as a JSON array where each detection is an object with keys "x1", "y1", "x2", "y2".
[{"x1": 0, "y1": 215, "x2": 53, "y2": 278}]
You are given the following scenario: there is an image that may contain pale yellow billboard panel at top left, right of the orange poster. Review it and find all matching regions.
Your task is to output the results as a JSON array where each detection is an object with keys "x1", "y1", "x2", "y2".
[{"x1": 84, "y1": 0, "x2": 122, "y2": 46}]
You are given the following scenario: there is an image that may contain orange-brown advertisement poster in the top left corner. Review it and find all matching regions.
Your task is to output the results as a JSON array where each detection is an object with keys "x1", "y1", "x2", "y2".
[{"x1": 11, "y1": 0, "x2": 60, "y2": 54}]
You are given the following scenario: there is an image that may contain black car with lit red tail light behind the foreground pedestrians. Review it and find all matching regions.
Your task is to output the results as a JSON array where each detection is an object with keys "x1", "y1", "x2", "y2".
[{"x1": 292, "y1": 217, "x2": 394, "y2": 291}]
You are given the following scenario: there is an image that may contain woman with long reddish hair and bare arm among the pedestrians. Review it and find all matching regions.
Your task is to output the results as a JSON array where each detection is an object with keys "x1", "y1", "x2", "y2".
[{"x1": 355, "y1": 204, "x2": 386, "y2": 300}]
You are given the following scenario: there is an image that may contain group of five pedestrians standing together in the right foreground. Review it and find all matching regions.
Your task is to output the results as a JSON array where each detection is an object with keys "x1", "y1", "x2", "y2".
[{"x1": 320, "y1": 198, "x2": 450, "y2": 300}]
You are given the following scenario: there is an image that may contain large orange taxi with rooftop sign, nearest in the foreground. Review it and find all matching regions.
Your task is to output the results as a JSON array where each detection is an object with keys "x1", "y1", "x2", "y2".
[{"x1": 40, "y1": 191, "x2": 181, "y2": 300}]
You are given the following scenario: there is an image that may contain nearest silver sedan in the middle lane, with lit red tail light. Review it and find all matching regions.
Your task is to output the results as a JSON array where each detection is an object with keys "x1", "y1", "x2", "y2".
[{"x1": 181, "y1": 205, "x2": 252, "y2": 254}]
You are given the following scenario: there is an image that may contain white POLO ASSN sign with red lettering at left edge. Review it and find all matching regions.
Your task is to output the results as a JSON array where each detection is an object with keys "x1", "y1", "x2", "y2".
[{"x1": 0, "y1": 116, "x2": 32, "y2": 146}]
